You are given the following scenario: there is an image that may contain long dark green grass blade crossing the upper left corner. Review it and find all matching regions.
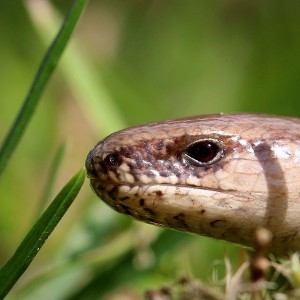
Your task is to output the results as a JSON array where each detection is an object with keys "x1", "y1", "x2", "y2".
[{"x1": 0, "y1": 0, "x2": 88, "y2": 176}]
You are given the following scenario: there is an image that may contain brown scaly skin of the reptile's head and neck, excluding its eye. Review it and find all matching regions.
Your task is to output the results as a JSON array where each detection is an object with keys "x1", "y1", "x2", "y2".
[{"x1": 86, "y1": 114, "x2": 300, "y2": 255}]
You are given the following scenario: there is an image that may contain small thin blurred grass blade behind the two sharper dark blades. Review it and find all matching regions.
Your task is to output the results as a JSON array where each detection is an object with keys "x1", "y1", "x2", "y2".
[{"x1": 37, "y1": 143, "x2": 66, "y2": 216}]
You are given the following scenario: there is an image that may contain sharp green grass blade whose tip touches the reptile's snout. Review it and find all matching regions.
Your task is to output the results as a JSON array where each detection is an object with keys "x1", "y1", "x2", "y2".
[{"x1": 0, "y1": 169, "x2": 86, "y2": 299}]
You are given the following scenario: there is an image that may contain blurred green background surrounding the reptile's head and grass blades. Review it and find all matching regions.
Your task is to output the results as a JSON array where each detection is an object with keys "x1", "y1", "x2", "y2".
[{"x1": 0, "y1": 0, "x2": 300, "y2": 299}]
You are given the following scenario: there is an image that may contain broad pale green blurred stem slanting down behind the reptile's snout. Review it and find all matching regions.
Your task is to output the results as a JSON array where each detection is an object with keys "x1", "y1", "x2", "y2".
[{"x1": 27, "y1": 2, "x2": 126, "y2": 136}]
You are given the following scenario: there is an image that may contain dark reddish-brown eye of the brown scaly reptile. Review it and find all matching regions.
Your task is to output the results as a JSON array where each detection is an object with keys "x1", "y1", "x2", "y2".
[{"x1": 183, "y1": 139, "x2": 223, "y2": 167}]
